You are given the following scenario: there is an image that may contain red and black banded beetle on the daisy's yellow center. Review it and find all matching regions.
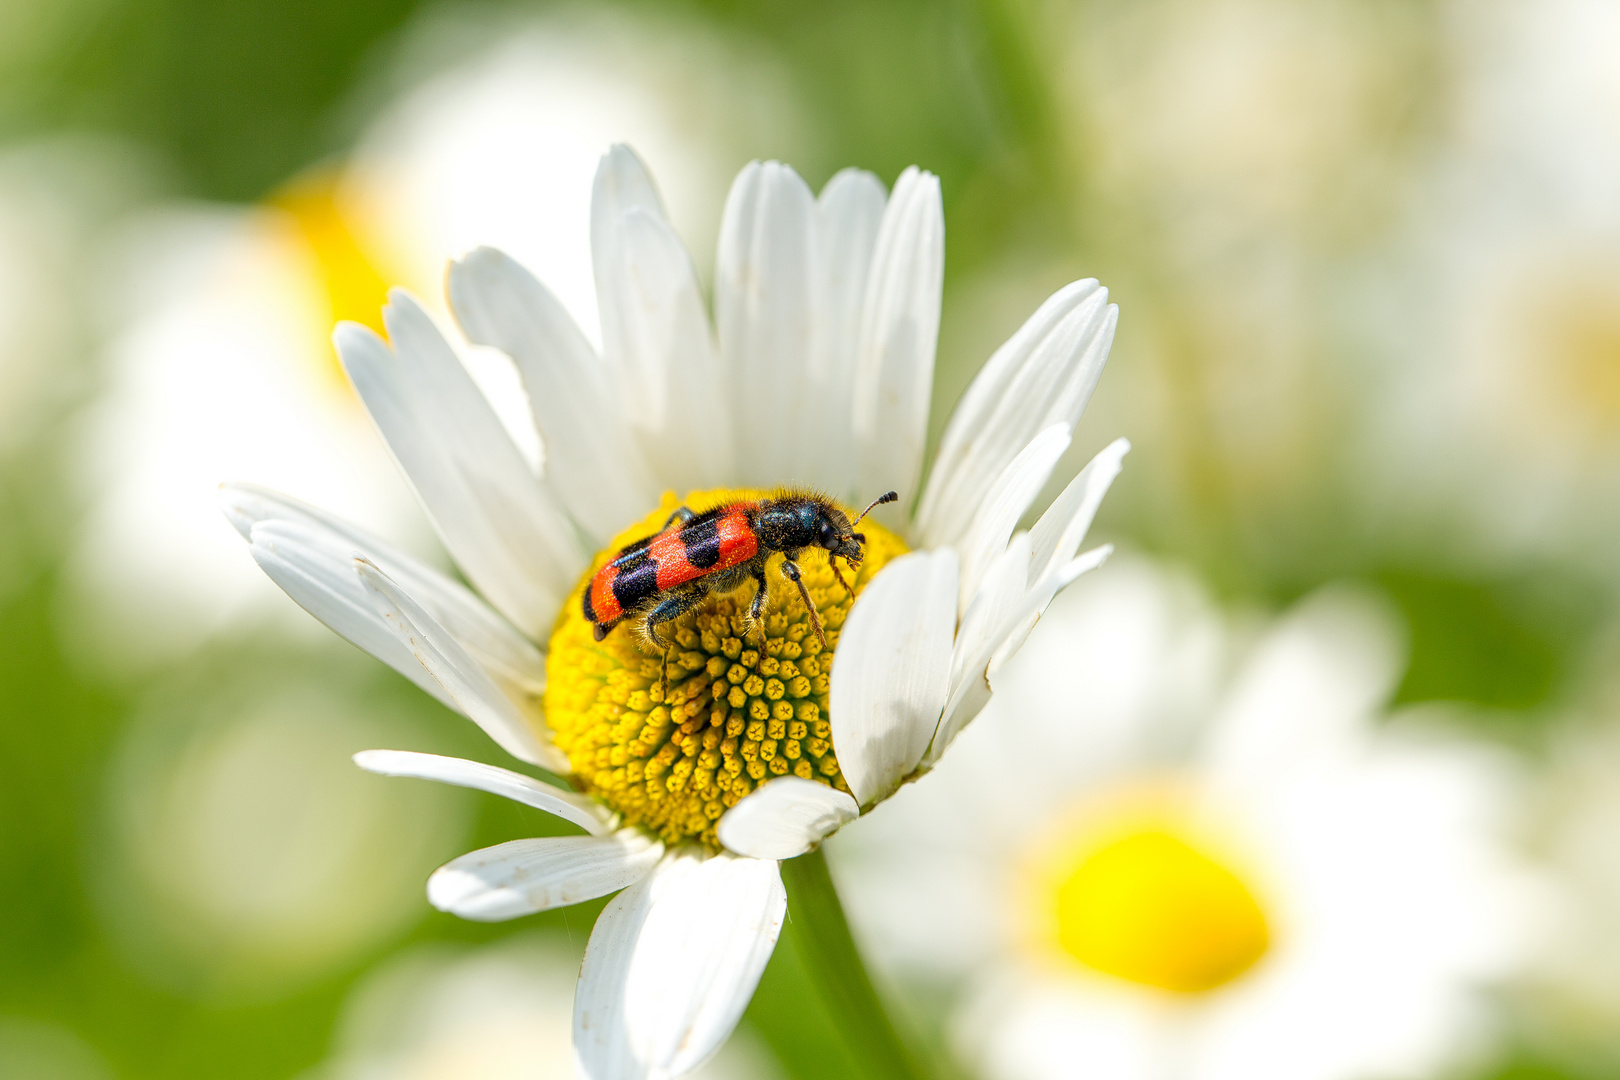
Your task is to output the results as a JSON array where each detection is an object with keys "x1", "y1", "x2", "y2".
[{"x1": 580, "y1": 489, "x2": 899, "y2": 690}]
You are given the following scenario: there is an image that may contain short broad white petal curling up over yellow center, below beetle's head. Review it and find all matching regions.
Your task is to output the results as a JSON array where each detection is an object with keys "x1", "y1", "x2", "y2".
[{"x1": 829, "y1": 549, "x2": 959, "y2": 806}]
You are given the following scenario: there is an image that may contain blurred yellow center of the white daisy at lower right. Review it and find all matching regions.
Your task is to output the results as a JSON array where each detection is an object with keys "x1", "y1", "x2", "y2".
[{"x1": 1037, "y1": 790, "x2": 1272, "y2": 994}]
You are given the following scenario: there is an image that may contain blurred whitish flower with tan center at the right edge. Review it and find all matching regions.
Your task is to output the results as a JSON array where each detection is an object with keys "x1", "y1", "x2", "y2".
[{"x1": 1366, "y1": 216, "x2": 1620, "y2": 575}]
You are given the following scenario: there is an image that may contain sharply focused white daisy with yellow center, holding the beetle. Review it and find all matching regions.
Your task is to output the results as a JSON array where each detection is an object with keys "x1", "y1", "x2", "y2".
[{"x1": 225, "y1": 146, "x2": 1126, "y2": 1080}]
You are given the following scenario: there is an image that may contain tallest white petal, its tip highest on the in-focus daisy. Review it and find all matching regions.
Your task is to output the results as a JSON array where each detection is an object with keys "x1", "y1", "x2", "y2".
[{"x1": 591, "y1": 147, "x2": 732, "y2": 492}]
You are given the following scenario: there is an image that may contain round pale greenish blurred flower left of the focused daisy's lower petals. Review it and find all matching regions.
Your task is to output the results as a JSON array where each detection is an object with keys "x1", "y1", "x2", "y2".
[{"x1": 96, "y1": 678, "x2": 467, "y2": 997}]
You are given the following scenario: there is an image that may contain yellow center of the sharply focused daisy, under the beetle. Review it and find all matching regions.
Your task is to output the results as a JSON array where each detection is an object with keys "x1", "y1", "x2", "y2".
[{"x1": 544, "y1": 489, "x2": 906, "y2": 848}]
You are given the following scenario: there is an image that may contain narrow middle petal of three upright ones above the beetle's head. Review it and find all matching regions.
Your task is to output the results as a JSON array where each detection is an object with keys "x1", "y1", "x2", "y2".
[{"x1": 807, "y1": 168, "x2": 889, "y2": 502}]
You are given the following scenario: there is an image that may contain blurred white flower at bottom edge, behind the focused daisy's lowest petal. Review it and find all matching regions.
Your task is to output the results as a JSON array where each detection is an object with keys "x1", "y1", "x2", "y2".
[{"x1": 303, "y1": 936, "x2": 776, "y2": 1080}]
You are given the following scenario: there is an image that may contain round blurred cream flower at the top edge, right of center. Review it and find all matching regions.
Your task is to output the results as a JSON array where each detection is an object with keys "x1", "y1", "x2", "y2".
[{"x1": 1059, "y1": 0, "x2": 1419, "y2": 249}]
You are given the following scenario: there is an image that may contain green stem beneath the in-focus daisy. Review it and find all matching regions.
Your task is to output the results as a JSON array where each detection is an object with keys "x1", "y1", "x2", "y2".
[{"x1": 782, "y1": 848, "x2": 928, "y2": 1080}]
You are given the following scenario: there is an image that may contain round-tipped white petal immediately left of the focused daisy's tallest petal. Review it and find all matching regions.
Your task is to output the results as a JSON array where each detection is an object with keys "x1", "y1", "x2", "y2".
[{"x1": 450, "y1": 248, "x2": 659, "y2": 542}]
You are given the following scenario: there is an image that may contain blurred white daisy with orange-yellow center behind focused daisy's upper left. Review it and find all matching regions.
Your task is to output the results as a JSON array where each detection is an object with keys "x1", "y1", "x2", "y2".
[{"x1": 75, "y1": 12, "x2": 792, "y2": 662}]
